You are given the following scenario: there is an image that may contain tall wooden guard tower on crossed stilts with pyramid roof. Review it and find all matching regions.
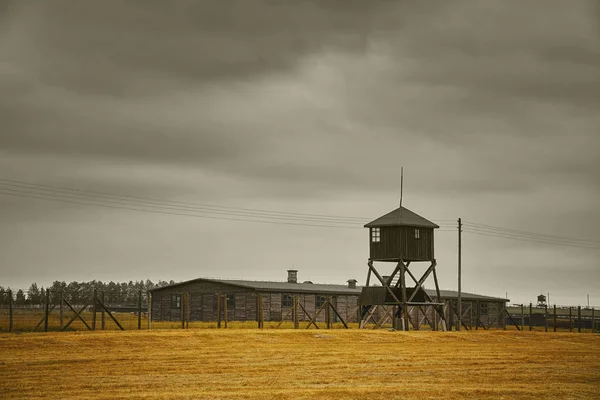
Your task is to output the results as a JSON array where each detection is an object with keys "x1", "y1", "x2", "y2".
[{"x1": 359, "y1": 206, "x2": 446, "y2": 330}]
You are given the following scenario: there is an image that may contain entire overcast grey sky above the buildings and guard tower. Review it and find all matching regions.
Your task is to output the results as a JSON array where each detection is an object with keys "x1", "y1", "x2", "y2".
[{"x1": 0, "y1": 0, "x2": 600, "y2": 305}]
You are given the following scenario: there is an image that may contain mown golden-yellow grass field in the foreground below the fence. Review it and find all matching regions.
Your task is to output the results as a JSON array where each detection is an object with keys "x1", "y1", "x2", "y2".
[{"x1": 0, "y1": 329, "x2": 600, "y2": 399}]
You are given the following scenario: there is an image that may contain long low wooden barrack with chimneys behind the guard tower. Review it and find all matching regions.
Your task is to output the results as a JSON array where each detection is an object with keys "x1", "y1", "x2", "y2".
[{"x1": 150, "y1": 270, "x2": 507, "y2": 327}]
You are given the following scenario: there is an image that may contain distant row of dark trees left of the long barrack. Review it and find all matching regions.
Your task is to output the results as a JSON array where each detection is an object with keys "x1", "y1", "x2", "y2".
[{"x1": 0, "y1": 279, "x2": 175, "y2": 306}]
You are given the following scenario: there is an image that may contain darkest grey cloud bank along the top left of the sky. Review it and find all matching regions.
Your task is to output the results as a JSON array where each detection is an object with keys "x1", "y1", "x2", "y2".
[{"x1": 1, "y1": 0, "x2": 404, "y2": 95}]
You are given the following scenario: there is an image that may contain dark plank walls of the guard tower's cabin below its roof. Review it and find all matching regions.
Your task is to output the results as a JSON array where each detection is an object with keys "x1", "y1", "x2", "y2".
[{"x1": 369, "y1": 226, "x2": 435, "y2": 261}]
